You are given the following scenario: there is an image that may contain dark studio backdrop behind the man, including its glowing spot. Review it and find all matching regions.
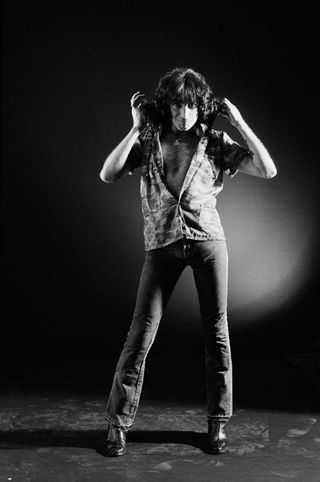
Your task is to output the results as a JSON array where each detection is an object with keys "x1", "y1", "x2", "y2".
[{"x1": 1, "y1": 2, "x2": 320, "y2": 409}]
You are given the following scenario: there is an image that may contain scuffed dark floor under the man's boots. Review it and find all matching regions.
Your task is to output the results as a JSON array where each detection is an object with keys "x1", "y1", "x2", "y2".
[{"x1": 0, "y1": 392, "x2": 320, "y2": 482}]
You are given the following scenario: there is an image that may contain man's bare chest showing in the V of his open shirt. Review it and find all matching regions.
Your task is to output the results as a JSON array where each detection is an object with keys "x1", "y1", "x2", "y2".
[{"x1": 161, "y1": 138, "x2": 198, "y2": 198}]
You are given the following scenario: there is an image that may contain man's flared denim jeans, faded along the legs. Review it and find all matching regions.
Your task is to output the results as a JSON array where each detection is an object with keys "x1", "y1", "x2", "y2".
[{"x1": 105, "y1": 239, "x2": 232, "y2": 431}]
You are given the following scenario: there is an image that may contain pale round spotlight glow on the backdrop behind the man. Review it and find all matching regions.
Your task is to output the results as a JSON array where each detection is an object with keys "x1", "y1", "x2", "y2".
[{"x1": 164, "y1": 176, "x2": 317, "y2": 325}]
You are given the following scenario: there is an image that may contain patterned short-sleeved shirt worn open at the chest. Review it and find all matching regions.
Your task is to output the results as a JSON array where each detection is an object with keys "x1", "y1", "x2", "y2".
[{"x1": 128, "y1": 124, "x2": 252, "y2": 251}]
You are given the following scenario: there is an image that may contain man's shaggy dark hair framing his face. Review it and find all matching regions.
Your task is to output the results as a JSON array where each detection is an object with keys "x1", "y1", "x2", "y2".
[{"x1": 143, "y1": 67, "x2": 220, "y2": 127}]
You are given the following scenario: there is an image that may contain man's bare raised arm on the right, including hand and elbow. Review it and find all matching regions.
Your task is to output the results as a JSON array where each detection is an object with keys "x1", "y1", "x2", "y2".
[{"x1": 223, "y1": 99, "x2": 277, "y2": 179}]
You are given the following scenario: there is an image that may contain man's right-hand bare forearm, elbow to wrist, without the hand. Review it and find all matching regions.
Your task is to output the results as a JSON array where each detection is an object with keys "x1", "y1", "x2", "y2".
[{"x1": 235, "y1": 118, "x2": 277, "y2": 179}]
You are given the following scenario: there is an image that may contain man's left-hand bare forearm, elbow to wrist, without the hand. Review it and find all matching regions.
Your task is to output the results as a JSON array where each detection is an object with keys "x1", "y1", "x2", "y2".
[{"x1": 100, "y1": 127, "x2": 140, "y2": 182}]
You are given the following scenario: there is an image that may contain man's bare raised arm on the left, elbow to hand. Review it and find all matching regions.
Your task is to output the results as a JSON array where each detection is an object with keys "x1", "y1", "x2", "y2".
[{"x1": 100, "y1": 92, "x2": 146, "y2": 182}]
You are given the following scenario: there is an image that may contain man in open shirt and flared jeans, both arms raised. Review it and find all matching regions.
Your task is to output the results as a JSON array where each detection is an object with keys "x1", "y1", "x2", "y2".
[{"x1": 100, "y1": 68, "x2": 276, "y2": 456}]
